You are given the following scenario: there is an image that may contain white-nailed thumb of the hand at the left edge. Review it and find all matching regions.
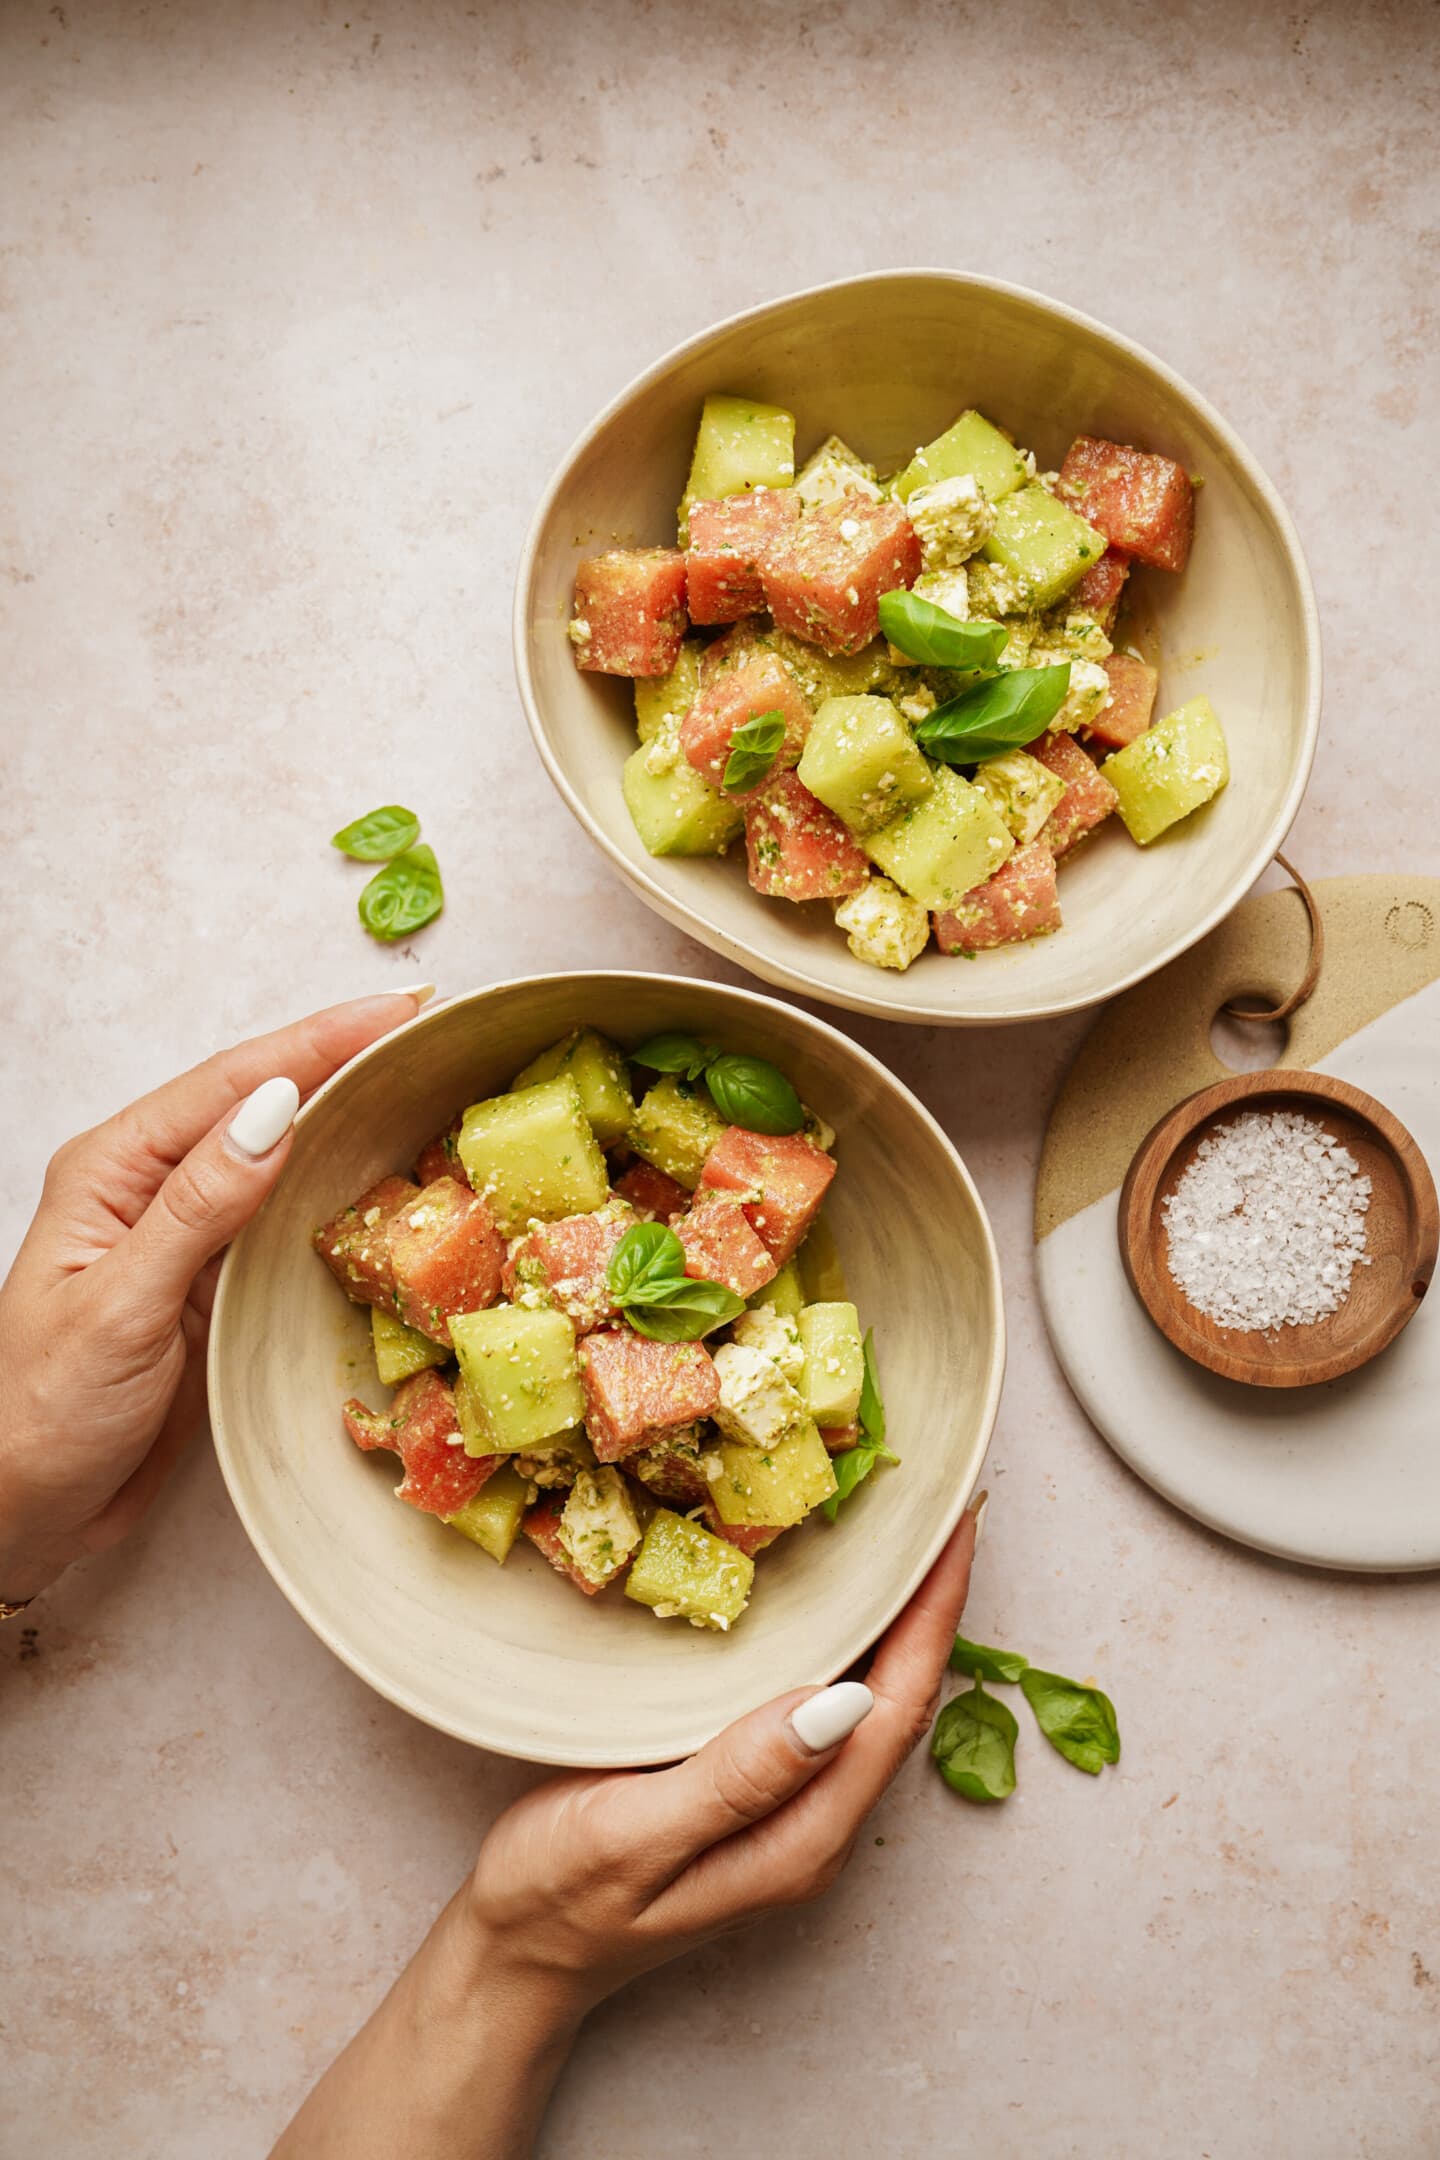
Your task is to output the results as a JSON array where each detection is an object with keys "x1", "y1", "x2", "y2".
[{"x1": 104, "y1": 1076, "x2": 300, "y2": 1324}]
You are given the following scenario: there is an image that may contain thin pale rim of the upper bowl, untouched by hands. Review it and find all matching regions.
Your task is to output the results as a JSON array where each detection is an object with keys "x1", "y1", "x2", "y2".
[{"x1": 512, "y1": 266, "x2": 1323, "y2": 1026}]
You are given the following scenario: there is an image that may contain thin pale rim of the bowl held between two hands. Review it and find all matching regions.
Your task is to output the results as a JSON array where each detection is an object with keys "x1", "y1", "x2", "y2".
[{"x1": 205, "y1": 968, "x2": 1006, "y2": 1769}]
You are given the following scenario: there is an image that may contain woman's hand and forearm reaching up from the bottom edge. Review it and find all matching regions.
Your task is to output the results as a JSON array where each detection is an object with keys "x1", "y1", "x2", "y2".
[{"x1": 274, "y1": 1510, "x2": 976, "y2": 2160}]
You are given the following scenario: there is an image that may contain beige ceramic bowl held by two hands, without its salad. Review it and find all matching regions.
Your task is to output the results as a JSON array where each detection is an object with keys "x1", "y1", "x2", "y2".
[{"x1": 209, "y1": 974, "x2": 1004, "y2": 1767}]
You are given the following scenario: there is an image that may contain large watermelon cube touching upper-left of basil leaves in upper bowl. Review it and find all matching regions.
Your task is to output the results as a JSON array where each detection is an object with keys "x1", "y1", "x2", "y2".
[{"x1": 760, "y1": 497, "x2": 920, "y2": 652}]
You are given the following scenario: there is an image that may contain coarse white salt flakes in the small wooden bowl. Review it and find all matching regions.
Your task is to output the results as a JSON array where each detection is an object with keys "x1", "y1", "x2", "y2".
[{"x1": 1164, "y1": 1110, "x2": 1371, "y2": 1328}]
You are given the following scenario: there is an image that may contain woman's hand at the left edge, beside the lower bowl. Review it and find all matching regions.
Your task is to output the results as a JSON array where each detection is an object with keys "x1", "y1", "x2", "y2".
[{"x1": 0, "y1": 989, "x2": 427, "y2": 1603}]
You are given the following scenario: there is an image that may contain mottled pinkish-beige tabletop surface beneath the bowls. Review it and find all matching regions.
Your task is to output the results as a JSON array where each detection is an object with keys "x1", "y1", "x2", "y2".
[{"x1": 0, "y1": 0, "x2": 1440, "y2": 2160}]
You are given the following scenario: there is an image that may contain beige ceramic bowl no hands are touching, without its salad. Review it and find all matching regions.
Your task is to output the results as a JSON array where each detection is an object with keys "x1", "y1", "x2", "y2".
[{"x1": 514, "y1": 270, "x2": 1319, "y2": 1024}]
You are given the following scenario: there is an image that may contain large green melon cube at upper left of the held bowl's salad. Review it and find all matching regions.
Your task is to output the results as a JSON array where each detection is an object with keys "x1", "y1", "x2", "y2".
[{"x1": 456, "y1": 1074, "x2": 609, "y2": 1238}]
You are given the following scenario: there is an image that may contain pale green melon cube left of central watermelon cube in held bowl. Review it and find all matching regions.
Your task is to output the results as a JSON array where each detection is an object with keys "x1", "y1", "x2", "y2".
[{"x1": 449, "y1": 1305, "x2": 585, "y2": 1456}]
